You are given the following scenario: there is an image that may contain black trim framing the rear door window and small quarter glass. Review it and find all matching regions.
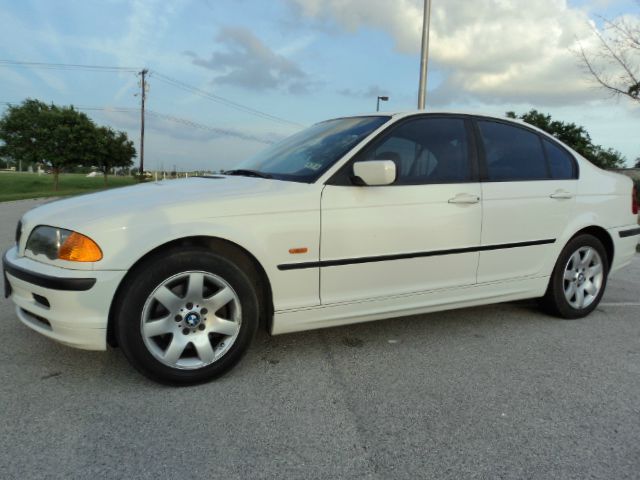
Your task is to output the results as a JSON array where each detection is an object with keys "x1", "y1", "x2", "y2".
[{"x1": 472, "y1": 115, "x2": 580, "y2": 183}]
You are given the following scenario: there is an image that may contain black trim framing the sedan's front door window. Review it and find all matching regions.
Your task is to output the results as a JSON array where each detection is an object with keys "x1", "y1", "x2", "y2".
[{"x1": 325, "y1": 113, "x2": 480, "y2": 188}]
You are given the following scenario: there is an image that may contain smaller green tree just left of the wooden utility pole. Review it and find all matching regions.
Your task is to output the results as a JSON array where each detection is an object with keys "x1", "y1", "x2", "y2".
[{"x1": 91, "y1": 127, "x2": 136, "y2": 185}]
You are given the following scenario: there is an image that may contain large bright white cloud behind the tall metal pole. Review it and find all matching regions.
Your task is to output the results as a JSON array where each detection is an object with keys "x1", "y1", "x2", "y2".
[{"x1": 288, "y1": 0, "x2": 640, "y2": 105}]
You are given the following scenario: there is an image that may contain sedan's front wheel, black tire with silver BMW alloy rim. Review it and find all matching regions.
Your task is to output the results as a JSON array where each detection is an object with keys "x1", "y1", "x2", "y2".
[{"x1": 115, "y1": 248, "x2": 259, "y2": 385}]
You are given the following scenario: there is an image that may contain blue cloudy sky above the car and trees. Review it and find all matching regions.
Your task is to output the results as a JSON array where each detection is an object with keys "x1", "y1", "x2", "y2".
[{"x1": 0, "y1": 0, "x2": 640, "y2": 171}]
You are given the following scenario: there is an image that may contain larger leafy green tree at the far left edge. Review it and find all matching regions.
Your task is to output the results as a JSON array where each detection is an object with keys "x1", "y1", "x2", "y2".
[{"x1": 0, "y1": 99, "x2": 95, "y2": 190}]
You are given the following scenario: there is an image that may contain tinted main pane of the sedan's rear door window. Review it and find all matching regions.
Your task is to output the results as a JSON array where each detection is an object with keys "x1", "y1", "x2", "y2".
[{"x1": 478, "y1": 120, "x2": 549, "y2": 181}]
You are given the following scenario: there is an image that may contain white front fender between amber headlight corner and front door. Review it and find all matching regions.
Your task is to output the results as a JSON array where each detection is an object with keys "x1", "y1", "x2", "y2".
[{"x1": 92, "y1": 210, "x2": 320, "y2": 310}]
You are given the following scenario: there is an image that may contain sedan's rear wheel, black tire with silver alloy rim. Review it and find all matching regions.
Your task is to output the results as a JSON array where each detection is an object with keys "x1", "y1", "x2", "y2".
[{"x1": 540, "y1": 234, "x2": 609, "y2": 319}]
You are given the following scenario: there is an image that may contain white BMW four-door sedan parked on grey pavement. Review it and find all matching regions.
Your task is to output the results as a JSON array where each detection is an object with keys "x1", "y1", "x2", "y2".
[{"x1": 3, "y1": 112, "x2": 640, "y2": 384}]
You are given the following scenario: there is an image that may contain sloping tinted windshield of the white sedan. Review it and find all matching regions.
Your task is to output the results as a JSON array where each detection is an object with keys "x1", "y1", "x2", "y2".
[{"x1": 231, "y1": 116, "x2": 391, "y2": 183}]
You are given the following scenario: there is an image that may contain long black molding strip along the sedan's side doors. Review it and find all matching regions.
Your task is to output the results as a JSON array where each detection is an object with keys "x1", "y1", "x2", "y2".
[{"x1": 278, "y1": 238, "x2": 556, "y2": 270}]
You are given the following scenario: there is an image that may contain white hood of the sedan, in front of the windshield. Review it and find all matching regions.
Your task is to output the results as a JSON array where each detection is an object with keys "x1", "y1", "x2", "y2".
[{"x1": 22, "y1": 176, "x2": 310, "y2": 232}]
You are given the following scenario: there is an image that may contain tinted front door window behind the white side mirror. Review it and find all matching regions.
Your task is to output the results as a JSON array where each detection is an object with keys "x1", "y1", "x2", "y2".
[{"x1": 358, "y1": 118, "x2": 471, "y2": 185}]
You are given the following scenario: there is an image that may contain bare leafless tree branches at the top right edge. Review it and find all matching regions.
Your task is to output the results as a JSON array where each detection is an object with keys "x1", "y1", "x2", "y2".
[{"x1": 578, "y1": 1, "x2": 640, "y2": 103}]
